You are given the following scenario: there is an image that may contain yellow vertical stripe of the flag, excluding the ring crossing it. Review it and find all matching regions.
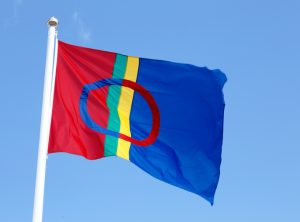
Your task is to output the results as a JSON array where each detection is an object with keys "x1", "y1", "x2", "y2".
[{"x1": 117, "y1": 56, "x2": 139, "y2": 160}]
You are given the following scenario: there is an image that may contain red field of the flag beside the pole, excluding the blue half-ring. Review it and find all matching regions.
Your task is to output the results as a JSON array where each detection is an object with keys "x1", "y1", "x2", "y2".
[{"x1": 48, "y1": 41, "x2": 116, "y2": 159}]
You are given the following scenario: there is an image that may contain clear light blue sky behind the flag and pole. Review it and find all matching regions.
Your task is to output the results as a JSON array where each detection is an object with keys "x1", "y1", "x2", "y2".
[{"x1": 0, "y1": 0, "x2": 300, "y2": 222}]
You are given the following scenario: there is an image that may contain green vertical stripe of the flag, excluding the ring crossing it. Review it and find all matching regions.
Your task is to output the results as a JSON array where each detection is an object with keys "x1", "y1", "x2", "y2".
[{"x1": 104, "y1": 54, "x2": 127, "y2": 156}]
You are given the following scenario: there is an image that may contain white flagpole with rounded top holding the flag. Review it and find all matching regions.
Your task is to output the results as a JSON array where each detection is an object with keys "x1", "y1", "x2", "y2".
[{"x1": 32, "y1": 17, "x2": 58, "y2": 222}]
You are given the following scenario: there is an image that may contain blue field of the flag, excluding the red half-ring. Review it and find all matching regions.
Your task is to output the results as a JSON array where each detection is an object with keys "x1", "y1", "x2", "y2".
[{"x1": 130, "y1": 59, "x2": 226, "y2": 204}]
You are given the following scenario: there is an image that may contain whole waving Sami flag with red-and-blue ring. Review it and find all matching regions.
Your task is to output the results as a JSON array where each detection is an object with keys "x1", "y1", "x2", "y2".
[{"x1": 48, "y1": 41, "x2": 226, "y2": 204}]
